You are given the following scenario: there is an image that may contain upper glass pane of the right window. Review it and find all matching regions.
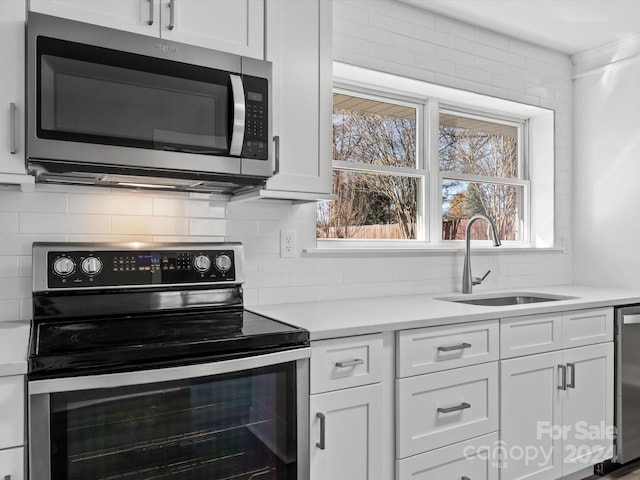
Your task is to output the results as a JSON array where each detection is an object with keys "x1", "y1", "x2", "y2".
[{"x1": 438, "y1": 112, "x2": 518, "y2": 178}]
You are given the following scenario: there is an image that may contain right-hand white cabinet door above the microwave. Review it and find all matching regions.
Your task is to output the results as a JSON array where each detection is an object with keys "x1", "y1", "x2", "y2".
[{"x1": 160, "y1": 0, "x2": 268, "y2": 59}]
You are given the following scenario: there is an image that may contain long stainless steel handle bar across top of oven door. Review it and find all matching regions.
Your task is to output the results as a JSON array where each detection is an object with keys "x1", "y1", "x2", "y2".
[{"x1": 29, "y1": 347, "x2": 311, "y2": 395}]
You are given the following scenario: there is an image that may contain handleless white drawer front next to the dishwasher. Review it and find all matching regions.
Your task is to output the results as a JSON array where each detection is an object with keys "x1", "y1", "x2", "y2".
[{"x1": 562, "y1": 308, "x2": 613, "y2": 348}]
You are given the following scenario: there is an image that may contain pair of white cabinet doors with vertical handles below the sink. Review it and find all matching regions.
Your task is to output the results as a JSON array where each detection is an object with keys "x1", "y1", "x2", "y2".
[{"x1": 500, "y1": 342, "x2": 613, "y2": 480}]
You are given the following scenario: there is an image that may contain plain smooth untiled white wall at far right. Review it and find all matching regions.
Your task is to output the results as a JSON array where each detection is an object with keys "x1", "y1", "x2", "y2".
[{"x1": 573, "y1": 51, "x2": 640, "y2": 288}]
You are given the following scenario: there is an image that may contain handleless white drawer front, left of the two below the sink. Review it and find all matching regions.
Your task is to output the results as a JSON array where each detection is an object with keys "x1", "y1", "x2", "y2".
[{"x1": 500, "y1": 313, "x2": 562, "y2": 358}]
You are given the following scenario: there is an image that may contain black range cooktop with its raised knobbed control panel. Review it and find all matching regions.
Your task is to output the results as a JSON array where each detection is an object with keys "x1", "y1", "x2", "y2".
[{"x1": 29, "y1": 243, "x2": 309, "y2": 378}]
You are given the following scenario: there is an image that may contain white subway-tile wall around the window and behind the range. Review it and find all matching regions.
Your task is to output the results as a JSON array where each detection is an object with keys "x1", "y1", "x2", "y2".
[{"x1": 0, "y1": 0, "x2": 572, "y2": 320}]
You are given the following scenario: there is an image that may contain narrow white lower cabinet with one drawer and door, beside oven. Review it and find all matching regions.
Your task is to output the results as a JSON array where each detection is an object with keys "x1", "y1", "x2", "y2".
[{"x1": 309, "y1": 333, "x2": 393, "y2": 480}]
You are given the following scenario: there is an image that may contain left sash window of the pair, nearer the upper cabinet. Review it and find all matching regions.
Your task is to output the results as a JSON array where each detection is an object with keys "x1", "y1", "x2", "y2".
[{"x1": 317, "y1": 91, "x2": 425, "y2": 240}]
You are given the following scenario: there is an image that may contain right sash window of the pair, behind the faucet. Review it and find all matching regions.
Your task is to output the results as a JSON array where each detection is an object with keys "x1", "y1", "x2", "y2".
[{"x1": 438, "y1": 109, "x2": 529, "y2": 241}]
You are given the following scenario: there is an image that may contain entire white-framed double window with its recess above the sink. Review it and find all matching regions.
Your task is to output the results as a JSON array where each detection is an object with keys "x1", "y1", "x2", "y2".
[{"x1": 316, "y1": 63, "x2": 554, "y2": 248}]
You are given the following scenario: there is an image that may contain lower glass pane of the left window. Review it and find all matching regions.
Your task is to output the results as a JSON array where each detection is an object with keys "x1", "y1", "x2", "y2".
[{"x1": 316, "y1": 169, "x2": 420, "y2": 239}]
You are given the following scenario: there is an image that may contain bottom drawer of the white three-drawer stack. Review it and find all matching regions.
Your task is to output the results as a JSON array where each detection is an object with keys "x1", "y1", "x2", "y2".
[{"x1": 396, "y1": 433, "x2": 498, "y2": 480}]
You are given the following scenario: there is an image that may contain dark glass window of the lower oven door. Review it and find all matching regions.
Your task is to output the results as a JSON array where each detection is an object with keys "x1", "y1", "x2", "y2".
[{"x1": 50, "y1": 362, "x2": 297, "y2": 480}]
